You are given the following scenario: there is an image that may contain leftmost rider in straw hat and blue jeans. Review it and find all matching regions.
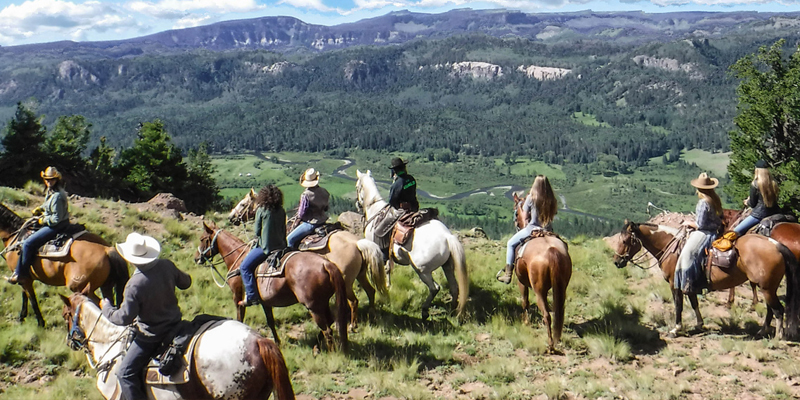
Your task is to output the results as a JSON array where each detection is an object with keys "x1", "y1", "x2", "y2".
[{"x1": 8, "y1": 166, "x2": 69, "y2": 284}]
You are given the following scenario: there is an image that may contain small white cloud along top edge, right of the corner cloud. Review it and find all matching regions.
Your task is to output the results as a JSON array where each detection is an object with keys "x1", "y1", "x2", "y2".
[{"x1": 126, "y1": 0, "x2": 265, "y2": 19}]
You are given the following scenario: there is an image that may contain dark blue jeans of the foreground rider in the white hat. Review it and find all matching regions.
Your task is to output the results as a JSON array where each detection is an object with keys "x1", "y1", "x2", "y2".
[{"x1": 117, "y1": 334, "x2": 161, "y2": 400}]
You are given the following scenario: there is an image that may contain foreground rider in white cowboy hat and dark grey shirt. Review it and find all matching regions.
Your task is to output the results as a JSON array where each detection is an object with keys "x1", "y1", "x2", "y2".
[{"x1": 100, "y1": 232, "x2": 192, "y2": 400}]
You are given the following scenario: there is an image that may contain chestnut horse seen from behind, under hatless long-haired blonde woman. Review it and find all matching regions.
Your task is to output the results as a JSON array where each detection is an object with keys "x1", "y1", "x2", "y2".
[{"x1": 514, "y1": 193, "x2": 572, "y2": 351}]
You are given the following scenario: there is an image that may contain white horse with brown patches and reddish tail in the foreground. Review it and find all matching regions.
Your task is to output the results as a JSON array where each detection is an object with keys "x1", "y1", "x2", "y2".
[{"x1": 61, "y1": 293, "x2": 294, "y2": 400}]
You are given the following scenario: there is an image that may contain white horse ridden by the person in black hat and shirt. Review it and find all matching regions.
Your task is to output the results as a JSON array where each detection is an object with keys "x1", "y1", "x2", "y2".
[{"x1": 356, "y1": 171, "x2": 469, "y2": 320}]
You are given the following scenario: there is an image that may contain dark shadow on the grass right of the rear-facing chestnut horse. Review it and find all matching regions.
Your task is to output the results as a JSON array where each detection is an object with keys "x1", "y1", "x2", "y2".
[{"x1": 567, "y1": 301, "x2": 667, "y2": 355}]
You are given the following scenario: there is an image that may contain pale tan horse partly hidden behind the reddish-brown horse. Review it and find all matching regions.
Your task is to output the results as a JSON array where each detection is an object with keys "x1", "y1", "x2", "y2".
[{"x1": 228, "y1": 189, "x2": 387, "y2": 329}]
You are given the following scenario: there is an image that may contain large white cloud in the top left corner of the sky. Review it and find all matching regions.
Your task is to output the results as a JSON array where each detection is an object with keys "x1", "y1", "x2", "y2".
[{"x1": 0, "y1": 0, "x2": 138, "y2": 43}]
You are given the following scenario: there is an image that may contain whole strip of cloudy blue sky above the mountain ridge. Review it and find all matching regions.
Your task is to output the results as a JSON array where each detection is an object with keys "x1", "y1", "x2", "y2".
[{"x1": 0, "y1": 0, "x2": 800, "y2": 46}]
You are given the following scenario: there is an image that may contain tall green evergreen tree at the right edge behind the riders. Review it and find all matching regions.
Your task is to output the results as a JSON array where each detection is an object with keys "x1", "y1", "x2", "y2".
[{"x1": 725, "y1": 40, "x2": 800, "y2": 212}]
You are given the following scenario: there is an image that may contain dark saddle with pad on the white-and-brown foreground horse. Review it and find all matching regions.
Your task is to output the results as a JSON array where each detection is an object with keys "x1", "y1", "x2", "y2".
[{"x1": 145, "y1": 314, "x2": 226, "y2": 385}]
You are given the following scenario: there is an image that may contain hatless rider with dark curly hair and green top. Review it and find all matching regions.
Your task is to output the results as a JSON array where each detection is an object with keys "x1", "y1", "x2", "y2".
[{"x1": 237, "y1": 185, "x2": 288, "y2": 307}]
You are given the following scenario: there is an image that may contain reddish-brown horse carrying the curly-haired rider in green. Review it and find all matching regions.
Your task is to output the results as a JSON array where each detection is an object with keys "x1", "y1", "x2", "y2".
[{"x1": 194, "y1": 222, "x2": 350, "y2": 351}]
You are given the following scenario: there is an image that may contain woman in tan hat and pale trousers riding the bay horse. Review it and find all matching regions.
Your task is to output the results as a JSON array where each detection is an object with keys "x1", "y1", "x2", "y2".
[{"x1": 674, "y1": 172, "x2": 722, "y2": 293}]
